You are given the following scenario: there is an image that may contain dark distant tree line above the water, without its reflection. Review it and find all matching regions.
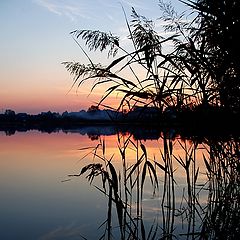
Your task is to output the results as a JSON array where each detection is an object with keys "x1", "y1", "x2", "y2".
[{"x1": 0, "y1": 105, "x2": 240, "y2": 136}]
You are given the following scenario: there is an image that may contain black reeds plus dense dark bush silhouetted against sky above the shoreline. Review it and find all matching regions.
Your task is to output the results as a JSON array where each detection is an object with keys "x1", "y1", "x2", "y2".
[{"x1": 63, "y1": 0, "x2": 240, "y2": 112}]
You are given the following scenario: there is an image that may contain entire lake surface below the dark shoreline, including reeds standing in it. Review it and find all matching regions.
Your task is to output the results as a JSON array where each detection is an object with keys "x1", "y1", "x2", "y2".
[{"x1": 0, "y1": 127, "x2": 240, "y2": 239}]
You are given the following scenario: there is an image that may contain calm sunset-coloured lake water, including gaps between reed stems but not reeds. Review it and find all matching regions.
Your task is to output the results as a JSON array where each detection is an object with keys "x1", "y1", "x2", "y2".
[{"x1": 0, "y1": 131, "x2": 238, "y2": 240}]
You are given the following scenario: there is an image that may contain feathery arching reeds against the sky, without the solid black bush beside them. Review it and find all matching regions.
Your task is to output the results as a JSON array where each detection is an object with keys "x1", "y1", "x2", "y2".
[{"x1": 63, "y1": 2, "x2": 210, "y2": 111}]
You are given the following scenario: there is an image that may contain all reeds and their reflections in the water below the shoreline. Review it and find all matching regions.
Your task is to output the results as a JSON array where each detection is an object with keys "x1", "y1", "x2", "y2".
[{"x1": 69, "y1": 134, "x2": 240, "y2": 239}]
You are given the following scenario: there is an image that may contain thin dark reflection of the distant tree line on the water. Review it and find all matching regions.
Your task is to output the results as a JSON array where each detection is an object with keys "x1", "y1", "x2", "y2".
[{"x1": 0, "y1": 124, "x2": 240, "y2": 140}]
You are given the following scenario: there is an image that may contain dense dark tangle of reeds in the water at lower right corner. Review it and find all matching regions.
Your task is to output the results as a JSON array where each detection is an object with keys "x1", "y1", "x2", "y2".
[{"x1": 202, "y1": 140, "x2": 240, "y2": 239}]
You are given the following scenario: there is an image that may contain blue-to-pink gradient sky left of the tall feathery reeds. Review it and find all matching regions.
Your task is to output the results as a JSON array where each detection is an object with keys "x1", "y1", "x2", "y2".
[{"x1": 0, "y1": 0, "x2": 187, "y2": 113}]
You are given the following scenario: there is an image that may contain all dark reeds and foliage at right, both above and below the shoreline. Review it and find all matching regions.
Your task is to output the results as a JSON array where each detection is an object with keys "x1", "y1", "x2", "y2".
[{"x1": 60, "y1": 0, "x2": 240, "y2": 240}]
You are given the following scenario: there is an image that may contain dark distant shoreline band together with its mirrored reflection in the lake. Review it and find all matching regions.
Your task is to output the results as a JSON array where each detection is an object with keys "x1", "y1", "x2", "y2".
[{"x1": 0, "y1": 108, "x2": 240, "y2": 139}]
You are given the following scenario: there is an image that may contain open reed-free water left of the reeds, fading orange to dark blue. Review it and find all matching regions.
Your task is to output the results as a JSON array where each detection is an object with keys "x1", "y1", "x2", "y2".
[{"x1": 0, "y1": 132, "x2": 106, "y2": 239}]
